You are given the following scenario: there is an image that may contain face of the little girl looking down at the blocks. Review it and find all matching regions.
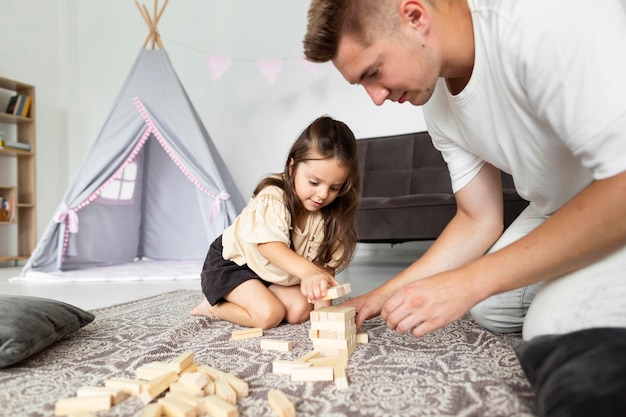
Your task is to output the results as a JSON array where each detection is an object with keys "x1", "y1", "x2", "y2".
[{"x1": 291, "y1": 154, "x2": 348, "y2": 212}]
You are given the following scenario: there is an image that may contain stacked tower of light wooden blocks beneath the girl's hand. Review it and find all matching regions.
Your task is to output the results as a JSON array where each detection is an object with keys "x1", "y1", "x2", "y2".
[{"x1": 309, "y1": 306, "x2": 356, "y2": 357}]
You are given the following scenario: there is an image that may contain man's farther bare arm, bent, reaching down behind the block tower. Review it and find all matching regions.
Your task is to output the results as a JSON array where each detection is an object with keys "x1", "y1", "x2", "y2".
[{"x1": 344, "y1": 164, "x2": 504, "y2": 327}]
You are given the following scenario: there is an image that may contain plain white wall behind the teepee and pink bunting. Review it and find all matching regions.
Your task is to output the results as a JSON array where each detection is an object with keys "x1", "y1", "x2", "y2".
[{"x1": 0, "y1": 0, "x2": 425, "y2": 235}]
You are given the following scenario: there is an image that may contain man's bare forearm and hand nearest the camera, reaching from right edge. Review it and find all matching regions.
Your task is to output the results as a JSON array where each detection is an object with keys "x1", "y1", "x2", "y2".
[{"x1": 381, "y1": 168, "x2": 626, "y2": 337}]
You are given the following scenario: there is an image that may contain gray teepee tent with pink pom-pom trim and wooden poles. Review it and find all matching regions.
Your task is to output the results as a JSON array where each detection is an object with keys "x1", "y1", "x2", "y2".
[{"x1": 21, "y1": 4, "x2": 244, "y2": 276}]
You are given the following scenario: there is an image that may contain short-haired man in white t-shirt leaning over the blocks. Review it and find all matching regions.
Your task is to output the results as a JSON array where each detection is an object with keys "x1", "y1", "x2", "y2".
[{"x1": 304, "y1": 0, "x2": 626, "y2": 340}]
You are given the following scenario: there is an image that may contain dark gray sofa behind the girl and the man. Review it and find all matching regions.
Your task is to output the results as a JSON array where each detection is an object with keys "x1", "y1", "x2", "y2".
[{"x1": 357, "y1": 132, "x2": 528, "y2": 243}]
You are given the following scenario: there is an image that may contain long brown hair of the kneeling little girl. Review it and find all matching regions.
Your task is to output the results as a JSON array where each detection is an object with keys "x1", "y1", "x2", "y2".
[{"x1": 253, "y1": 116, "x2": 360, "y2": 270}]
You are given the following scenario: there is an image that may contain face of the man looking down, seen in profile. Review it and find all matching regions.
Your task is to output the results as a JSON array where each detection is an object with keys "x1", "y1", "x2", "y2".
[{"x1": 332, "y1": 31, "x2": 438, "y2": 106}]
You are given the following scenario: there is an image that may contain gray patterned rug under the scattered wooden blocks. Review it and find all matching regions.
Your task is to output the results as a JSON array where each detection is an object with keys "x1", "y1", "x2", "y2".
[{"x1": 0, "y1": 290, "x2": 536, "y2": 417}]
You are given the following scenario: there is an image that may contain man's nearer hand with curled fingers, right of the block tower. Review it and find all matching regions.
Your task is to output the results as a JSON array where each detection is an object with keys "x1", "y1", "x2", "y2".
[{"x1": 381, "y1": 270, "x2": 478, "y2": 337}]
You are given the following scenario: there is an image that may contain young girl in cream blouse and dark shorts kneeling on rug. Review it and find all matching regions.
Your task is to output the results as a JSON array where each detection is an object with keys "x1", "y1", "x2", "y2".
[{"x1": 190, "y1": 116, "x2": 360, "y2": 329}]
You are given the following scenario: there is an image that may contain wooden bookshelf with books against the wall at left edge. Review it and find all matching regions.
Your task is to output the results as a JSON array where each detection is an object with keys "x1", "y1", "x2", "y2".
[{"x1": 0, "y1": 77, "x2": 37, "y2": 262}]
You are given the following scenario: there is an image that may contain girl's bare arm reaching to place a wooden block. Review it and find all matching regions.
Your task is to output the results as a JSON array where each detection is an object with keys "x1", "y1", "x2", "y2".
[{"x1": 259, "y1": 242, "x2": 339, "y2": 301}]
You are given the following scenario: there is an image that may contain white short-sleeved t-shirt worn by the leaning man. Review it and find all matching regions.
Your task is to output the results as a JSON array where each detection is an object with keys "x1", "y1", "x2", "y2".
[{"x1": 423, "y1": 0, "x2": 626, "y2": 215}]
